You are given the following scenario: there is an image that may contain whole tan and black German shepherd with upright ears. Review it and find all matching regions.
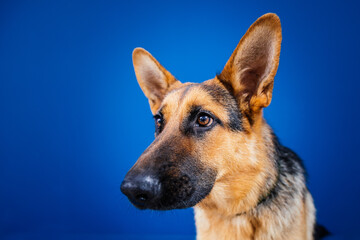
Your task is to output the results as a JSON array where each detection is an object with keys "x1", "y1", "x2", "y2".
[{"x1": 121, "y1": 13, "x2": 326, "y2": 240}]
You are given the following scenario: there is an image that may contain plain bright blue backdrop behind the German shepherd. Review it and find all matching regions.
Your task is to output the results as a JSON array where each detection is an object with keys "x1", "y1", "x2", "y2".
[{"x1": 0, "y1": 0, "x2": 360, "y2": 239}]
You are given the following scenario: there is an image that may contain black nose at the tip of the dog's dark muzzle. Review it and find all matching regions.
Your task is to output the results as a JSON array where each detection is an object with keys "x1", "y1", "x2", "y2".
[{"x1": 120, "y1": 176, "x2": 161, "y2": 209}]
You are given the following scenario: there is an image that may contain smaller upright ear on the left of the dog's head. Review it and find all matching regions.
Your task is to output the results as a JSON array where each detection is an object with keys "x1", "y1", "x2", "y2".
[{"x1": 132, "y1": 48, "x2": 180, "y2": 114}]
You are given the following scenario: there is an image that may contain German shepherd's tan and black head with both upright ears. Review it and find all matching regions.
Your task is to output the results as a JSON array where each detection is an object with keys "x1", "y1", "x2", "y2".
[{"x1": 121, "y1": 14, "x2": 281, "y2": 210}]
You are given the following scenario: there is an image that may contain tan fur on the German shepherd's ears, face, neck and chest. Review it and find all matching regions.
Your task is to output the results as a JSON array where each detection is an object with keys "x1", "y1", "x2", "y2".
[{"x1": 133, "y1": 14, "x2": 315, "y2": 240}]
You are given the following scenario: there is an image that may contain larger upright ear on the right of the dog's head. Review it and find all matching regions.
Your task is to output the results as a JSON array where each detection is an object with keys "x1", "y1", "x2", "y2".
[{"x1": 218, "y1": 13, "x2": 281, "y2": 114}]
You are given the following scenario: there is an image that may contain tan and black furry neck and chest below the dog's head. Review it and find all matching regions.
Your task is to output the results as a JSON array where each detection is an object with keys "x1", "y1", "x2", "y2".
[{"x1": 194, "y1": 122, "x2": 313, "y2": 240}]
